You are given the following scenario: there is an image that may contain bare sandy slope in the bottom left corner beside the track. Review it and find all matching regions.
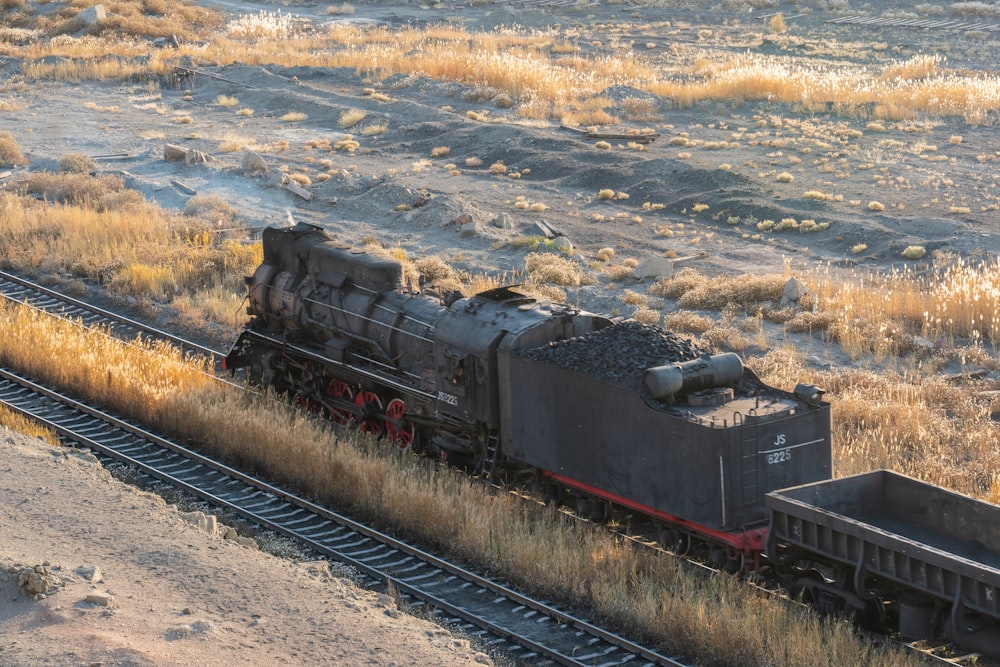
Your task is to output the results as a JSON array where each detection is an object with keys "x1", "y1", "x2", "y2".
[{"x1": 0, "y1": 428, "x2": 492, "y2": 667}]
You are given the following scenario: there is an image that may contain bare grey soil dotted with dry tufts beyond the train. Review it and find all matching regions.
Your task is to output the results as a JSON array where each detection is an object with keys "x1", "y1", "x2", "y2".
[{"x1": 7, "y1": 2, "x2": 1000, "y2": 330}]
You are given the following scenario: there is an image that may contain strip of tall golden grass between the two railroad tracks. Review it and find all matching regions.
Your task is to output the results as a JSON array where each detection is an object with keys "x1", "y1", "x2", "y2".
[{"x1": 0, "y1": 306, "x2": 908, "y2": 667}]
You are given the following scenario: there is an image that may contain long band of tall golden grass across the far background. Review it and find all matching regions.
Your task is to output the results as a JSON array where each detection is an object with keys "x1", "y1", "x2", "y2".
[{"x1": 11, "y1": 16, "x2": 1000, "y2": 125}]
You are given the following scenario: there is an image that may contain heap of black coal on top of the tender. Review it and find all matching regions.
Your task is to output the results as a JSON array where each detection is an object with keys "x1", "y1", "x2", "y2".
[{"x1": 519, "y1": 322, "x2": 706, "y2": 391}]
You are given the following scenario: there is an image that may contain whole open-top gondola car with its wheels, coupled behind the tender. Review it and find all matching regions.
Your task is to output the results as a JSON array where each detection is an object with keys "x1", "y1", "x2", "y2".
[{"x1": 767, "y1": 470, "x2": 1000, "y2": 658}]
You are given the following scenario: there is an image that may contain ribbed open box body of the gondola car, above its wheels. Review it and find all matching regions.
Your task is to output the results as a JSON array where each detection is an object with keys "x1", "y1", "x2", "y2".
[{"x1": 766, "y1": 470, "x2": 1000, "y2": 620}]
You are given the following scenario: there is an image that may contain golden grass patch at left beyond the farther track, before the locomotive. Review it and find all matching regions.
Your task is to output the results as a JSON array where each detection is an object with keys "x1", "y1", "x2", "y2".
[{"x1": 0, "y1": 188, "x2": 263, "y2": 331}]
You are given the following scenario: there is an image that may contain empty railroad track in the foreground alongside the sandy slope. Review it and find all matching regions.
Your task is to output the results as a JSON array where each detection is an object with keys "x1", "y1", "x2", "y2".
[{"x1": 0, "y1": 369, "x2": 683, "y2": 667}]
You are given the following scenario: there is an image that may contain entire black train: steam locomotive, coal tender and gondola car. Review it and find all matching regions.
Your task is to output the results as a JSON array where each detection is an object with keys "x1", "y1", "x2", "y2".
[{"x1": 223, "y1": 224, "x2": 1000, "y2": 657}]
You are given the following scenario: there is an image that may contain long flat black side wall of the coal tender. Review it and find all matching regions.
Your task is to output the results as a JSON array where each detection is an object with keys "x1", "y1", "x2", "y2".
[{"x1": 499, "y1": 352, "x2": 748, "y2": 530}]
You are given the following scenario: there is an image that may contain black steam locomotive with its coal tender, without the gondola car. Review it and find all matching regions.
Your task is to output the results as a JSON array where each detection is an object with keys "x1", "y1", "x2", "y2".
[{"x1": 225, "y1": 224, "x2": 831, "y2": 569}]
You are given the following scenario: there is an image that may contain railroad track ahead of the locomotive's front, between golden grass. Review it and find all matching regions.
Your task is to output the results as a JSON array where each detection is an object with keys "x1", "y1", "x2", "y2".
[{"x1": 0, "y1": 271, "x2": 225, "y2": 369}]
